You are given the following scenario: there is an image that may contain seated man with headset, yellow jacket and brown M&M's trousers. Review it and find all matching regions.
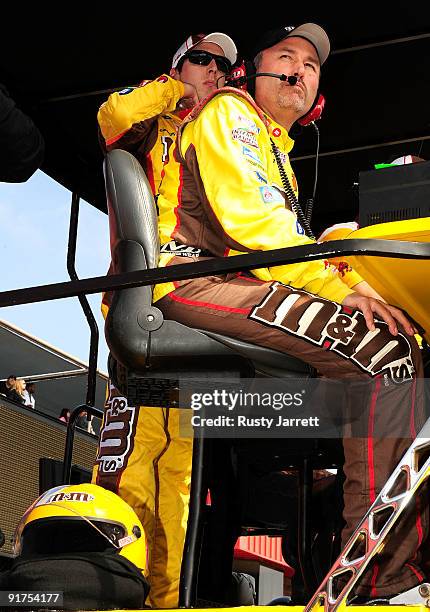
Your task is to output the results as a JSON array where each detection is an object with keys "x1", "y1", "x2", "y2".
[{"x1": 154, "y1": 24, "x2": 428, "y2": 598}]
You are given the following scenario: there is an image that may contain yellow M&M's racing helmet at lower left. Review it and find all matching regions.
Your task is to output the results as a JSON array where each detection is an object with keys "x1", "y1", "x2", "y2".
[{"x1": 14, "y1": 483, "x2": 146, "y2": 572}]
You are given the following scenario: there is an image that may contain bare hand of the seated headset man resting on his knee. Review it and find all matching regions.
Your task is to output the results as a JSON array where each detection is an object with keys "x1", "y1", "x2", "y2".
[{"x1": 342, "y1": 293, "x2": 417, "y2": 336}]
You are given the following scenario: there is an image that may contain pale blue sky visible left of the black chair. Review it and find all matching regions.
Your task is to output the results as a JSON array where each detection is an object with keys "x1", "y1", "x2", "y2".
[{"x1": 0, "y1": 171, "x2": 110, "y2": 372}]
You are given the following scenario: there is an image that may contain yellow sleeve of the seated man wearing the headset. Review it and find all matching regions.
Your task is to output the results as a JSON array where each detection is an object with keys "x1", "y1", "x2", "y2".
[{"x1": 181, "y1": 94, "x2": 352, "y2": 302}]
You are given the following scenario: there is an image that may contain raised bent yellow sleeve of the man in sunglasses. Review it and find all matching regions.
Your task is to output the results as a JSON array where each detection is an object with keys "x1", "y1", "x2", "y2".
[{"x1": 97, "y1": 74, "x2": 184, "y2": 147}]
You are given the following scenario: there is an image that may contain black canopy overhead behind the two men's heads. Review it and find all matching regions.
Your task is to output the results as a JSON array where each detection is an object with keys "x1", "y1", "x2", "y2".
[{"x1": 0, "y1": 8, "x2": 430, "y2": 227}]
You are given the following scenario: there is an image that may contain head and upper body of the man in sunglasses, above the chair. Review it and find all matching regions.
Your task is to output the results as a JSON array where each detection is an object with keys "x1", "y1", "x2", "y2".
[{"x1": 97, "y1": 32, "x2": 237, "y2": 195}]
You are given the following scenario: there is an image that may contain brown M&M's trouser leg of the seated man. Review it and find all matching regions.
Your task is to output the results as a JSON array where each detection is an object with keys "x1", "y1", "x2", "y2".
[{"x1": 157, "y1": 275, "x2": 428, "y2": 595}]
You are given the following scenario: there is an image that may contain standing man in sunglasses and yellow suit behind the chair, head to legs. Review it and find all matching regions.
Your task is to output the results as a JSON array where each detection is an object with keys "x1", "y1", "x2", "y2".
[{"x1": 93, "y1": 32, "x2": 237, "y2": 608}]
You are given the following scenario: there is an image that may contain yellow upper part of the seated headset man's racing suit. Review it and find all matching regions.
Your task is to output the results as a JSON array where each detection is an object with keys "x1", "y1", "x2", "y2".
[{"x1": 154, "y1": 88, "x2": 351, "y2": 302}]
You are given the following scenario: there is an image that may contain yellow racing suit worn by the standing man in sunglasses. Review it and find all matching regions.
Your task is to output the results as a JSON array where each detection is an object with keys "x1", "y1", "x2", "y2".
[{"x1": 93, "y1": 75, "x2": 192, "y2": 608}]
